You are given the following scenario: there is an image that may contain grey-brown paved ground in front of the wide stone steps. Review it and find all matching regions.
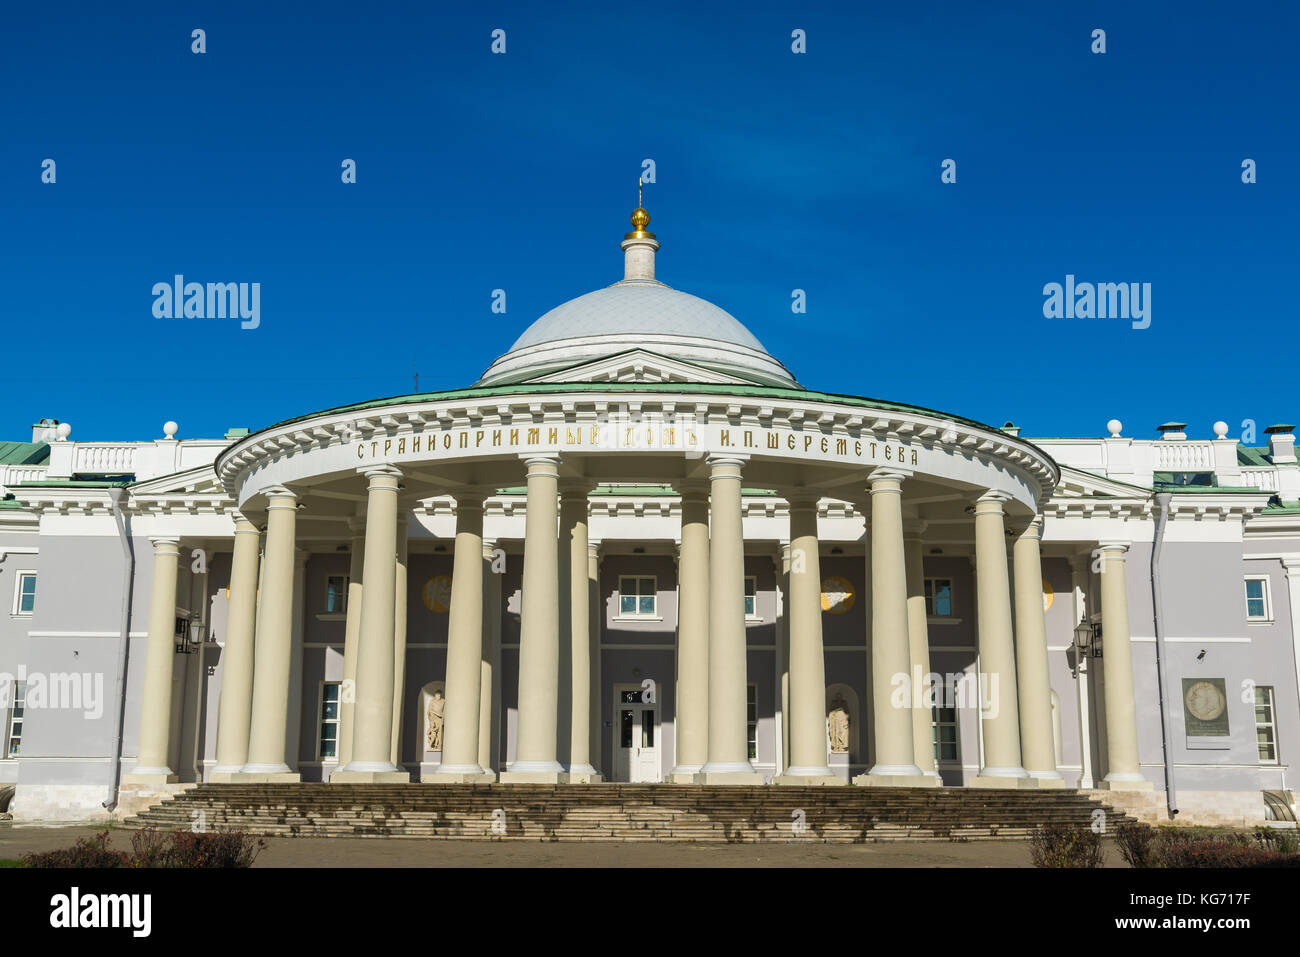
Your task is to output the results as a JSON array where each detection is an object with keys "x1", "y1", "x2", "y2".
[{"x1": 0, "y1": 824, "x2": 1125, "y2": 867}]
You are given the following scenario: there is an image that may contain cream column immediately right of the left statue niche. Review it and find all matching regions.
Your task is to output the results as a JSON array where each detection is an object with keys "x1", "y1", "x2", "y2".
[{"x1": 434, "y1": 492, "x2": 494, "y2": 784}]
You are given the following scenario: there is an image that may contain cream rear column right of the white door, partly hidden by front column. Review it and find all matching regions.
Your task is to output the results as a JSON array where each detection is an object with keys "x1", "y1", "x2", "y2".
[{"x1": 668, "y1": 482, "x2": 709, "y2": 784}]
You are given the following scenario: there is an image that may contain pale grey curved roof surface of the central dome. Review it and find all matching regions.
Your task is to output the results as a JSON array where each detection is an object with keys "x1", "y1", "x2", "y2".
[{"x1": 510, "y1": 280, "x2": 767, "y2": 354}]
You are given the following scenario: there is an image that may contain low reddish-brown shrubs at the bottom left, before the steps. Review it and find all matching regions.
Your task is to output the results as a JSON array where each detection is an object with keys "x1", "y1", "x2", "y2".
[{"x1": 22, "y1": 828, "x2": 267, "y2": 867}]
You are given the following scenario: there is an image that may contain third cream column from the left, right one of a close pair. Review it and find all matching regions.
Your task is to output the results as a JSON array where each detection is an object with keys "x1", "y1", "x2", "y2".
[{"x1": 239, "y1": 486, "x2": 300, "y2": 783}]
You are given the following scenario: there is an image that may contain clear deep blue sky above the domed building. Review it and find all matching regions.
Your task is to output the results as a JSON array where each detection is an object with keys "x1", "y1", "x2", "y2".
[{"x1": 0, "y1": 3, "x2": 1300, "y2": 441}]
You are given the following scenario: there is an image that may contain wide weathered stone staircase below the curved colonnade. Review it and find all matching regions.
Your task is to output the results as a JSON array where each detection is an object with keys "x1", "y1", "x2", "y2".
[{"x1": 125, "y1": 784, "x2": 1130, "y2": 844}]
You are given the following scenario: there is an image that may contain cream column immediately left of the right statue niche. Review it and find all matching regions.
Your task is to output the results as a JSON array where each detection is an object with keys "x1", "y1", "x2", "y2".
[{"x1": 776, "y1": 493, "x2": 844, "y2": 785}]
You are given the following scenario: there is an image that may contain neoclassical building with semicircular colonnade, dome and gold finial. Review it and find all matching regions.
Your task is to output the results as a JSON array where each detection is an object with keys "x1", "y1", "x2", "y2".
[{"x1": 0, "y1": 208, "x2": 1300, "y2": 822}]
